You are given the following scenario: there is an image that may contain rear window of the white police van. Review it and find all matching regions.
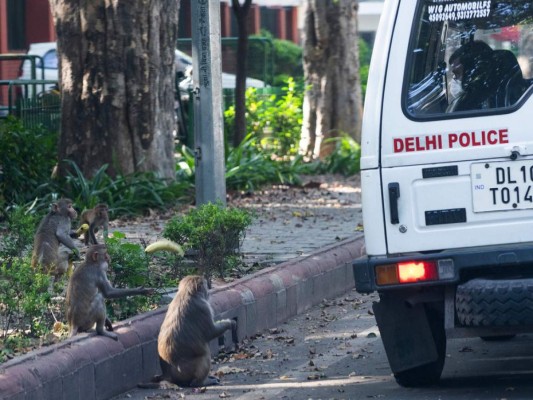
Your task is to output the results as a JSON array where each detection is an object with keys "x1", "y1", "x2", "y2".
[{"x1": 403, "y1": 0, "x2": 533, "y2": 118}]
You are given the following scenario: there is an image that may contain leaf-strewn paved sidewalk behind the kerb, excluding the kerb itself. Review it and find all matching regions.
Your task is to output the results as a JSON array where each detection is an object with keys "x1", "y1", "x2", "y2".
[{"x1": 110, "y1": 175, "x2": 362, "y2": 266}]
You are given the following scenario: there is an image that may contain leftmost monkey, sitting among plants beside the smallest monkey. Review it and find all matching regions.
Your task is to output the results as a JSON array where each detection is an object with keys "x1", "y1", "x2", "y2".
[{"x1": 31, "y1": 199, "x2": 79, "y2": 280}]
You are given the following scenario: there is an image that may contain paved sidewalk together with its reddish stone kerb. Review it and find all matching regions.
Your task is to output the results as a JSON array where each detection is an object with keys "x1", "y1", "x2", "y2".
[{"x1": 0, "y1": 177, "x2": 364, "y2": 400}]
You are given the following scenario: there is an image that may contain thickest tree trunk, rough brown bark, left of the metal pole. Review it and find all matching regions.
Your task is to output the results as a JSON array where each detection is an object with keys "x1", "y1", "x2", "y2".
[{"x1": 50, "y1": 0, "x2": 179, "y2": 179}]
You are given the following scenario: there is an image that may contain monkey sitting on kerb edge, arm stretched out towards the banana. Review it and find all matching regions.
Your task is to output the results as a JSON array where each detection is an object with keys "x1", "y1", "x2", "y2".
[{"x1": 66, "y1": 244, "x2": 153, "y2": 340}]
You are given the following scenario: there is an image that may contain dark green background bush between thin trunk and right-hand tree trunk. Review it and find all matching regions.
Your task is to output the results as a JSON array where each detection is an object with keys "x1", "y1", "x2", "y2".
[{"x1": 248, "y1": 29, "x2": 303, "y2": 86}]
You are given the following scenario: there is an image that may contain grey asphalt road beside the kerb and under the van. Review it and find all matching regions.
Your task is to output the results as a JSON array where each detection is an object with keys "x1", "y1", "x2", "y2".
[{"x1": 115, "y1": 291, "x2": 533, "y2": 400}]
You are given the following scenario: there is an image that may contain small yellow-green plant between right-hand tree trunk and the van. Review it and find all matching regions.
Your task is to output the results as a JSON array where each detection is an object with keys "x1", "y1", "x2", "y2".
[{"x1": 320, "y1": 135, "x2": 361, "y2": 176}]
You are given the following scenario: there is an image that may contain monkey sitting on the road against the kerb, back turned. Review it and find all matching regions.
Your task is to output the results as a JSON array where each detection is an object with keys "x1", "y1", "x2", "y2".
[{"x1": 142, "y1": 275, "x2": 237, "y2": 388}]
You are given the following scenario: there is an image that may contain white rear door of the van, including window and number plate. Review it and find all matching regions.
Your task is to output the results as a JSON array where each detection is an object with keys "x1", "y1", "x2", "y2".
[{"x1": 379, "y1": 0, "x2": 533, "y2": 254}]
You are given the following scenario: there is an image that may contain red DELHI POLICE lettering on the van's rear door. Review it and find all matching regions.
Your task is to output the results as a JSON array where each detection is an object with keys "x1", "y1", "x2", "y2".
[{"x1": 392, "y1": 129, "x2": 509, "y2": 153}]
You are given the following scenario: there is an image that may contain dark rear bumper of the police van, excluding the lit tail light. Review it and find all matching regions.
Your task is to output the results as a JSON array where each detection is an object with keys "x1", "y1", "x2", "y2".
[{"x1": 353, "y1": 242, "x2": 533, "y2": 293}]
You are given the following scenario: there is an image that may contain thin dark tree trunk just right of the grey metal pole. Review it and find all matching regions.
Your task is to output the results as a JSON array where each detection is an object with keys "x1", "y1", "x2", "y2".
[{"x1": 231, "y1": 0, "x2": 252, "y2": 147}]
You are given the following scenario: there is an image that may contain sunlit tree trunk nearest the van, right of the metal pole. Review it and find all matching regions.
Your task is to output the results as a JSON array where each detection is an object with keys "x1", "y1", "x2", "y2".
[{"x1": 300, "y1": 0, "x2": 362, "y2": 158}]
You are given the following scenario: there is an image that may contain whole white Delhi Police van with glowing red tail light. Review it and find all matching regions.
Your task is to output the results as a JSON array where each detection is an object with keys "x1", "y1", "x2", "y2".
[{"x1": 354, "y1": 0, "x2": 533, "y2": 386}]
